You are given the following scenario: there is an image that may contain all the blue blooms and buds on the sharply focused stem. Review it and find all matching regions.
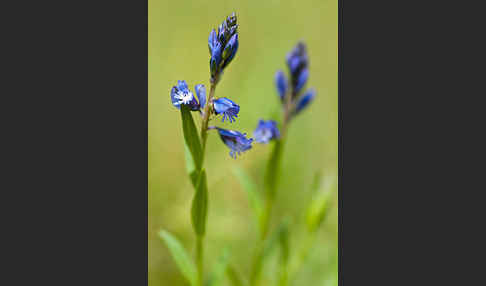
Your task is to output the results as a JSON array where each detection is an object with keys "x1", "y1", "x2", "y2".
[{"x1": 170, "y1": 13, "x2": 253, "y2": 158}]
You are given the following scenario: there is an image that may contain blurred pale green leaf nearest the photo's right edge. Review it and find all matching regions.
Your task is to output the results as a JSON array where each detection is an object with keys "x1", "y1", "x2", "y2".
[{"x1": 307, "y1": 174, "x2": 335, "y2": 232}]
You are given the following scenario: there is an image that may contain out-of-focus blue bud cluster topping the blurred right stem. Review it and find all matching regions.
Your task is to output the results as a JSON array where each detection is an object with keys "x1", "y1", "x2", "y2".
[{"x1": 275, "y1": 42, "x2": 316, "y2": 116}]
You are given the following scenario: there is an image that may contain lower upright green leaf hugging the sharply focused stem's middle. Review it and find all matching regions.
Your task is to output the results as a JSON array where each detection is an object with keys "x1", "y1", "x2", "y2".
[{"x1": 191, "y1": 169, "x2": 208, "y2": 236}]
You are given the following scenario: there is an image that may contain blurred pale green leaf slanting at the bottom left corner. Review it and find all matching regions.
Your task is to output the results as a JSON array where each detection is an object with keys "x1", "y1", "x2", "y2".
[{"x1": 159, "y1": 230, "x2": 197, "y2": 286}]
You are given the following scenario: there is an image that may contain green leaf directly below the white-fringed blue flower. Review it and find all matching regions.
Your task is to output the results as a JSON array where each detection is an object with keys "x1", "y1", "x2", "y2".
[{"x1": 181, "y1": 104, "x2": 202, "y2": 170}]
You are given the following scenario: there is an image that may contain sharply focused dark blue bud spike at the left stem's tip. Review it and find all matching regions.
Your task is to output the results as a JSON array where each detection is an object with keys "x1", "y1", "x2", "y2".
[{"x1": 208, "y1": 13, "x2": 238, "y2": 82}]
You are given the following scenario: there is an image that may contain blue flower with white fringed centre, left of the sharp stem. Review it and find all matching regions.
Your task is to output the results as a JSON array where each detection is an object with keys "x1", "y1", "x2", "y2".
[{"x1": 170, "y1": 80, "x2": 206, "y2": 111}]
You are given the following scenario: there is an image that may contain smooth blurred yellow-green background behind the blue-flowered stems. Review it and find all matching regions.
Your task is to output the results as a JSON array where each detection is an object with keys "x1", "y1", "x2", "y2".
[{"x1": 148, "y1": 0, "x2": 338, "y2": 286}]
